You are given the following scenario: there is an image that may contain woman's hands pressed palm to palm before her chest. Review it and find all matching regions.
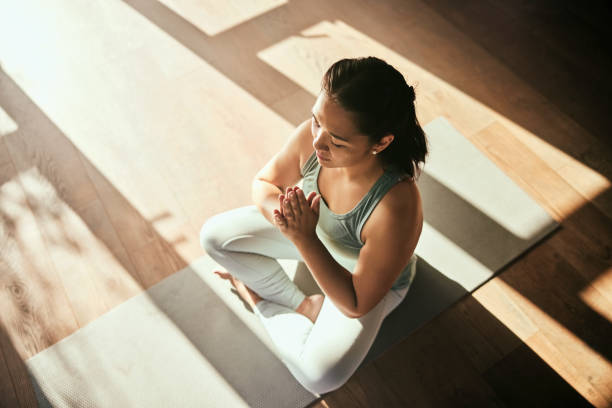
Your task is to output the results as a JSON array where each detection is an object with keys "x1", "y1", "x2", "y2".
[{"x1": 274, "y1": 187, "x2": 321, "y2": 244}]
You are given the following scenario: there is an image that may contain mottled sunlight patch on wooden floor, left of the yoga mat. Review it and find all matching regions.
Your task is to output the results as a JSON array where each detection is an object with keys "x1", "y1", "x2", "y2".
[{"x1": 0, "y1": 168, "x2": 141, "y2": 326}]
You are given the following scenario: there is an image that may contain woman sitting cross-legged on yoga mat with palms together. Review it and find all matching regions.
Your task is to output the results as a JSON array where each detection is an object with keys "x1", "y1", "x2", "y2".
[{"x1": 201, "y1": 57, "x2": 427, "y2": 394}]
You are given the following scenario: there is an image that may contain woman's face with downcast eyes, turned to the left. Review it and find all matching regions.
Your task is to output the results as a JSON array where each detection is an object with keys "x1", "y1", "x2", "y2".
[{"x1": 310, "y1": 92, "x2": 374, "y2": 167}]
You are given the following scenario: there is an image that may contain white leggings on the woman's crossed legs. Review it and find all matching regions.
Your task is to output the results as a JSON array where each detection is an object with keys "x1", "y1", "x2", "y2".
[{"x1": 200, "y1": 205, "x2": 409, "y2": 396}]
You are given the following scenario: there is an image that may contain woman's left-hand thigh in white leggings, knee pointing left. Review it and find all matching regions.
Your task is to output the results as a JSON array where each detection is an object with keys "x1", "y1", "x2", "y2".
[{"x1": 200, "y1": 205, "x2": 302, "y2": 261}]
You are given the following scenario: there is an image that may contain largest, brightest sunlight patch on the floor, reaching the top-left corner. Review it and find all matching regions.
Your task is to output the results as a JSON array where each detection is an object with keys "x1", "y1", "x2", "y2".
[{"x1": 0, "y1": 0, "x2": 293, "y2": 250}]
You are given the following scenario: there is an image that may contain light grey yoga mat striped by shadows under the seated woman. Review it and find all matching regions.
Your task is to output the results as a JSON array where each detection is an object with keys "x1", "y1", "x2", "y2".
[{"x1": 26, "y1": 118, "x2": 557, "y2": 407}]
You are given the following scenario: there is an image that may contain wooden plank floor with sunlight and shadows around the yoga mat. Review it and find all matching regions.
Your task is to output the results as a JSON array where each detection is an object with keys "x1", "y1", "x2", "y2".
[{"x1": 0, "y1": 0, "x2": 612, "y2": 408}]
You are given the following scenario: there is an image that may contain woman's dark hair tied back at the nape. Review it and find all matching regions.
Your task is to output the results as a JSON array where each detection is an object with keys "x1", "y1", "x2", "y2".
[{"x1": 321, "y1": 57, "x2": 428, "y2": 178}]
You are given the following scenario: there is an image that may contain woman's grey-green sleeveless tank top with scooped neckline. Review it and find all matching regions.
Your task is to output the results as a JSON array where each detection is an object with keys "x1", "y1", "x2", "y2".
[{"x1": 301, "y1": 151, "x2": 417, "y2": 290}]
